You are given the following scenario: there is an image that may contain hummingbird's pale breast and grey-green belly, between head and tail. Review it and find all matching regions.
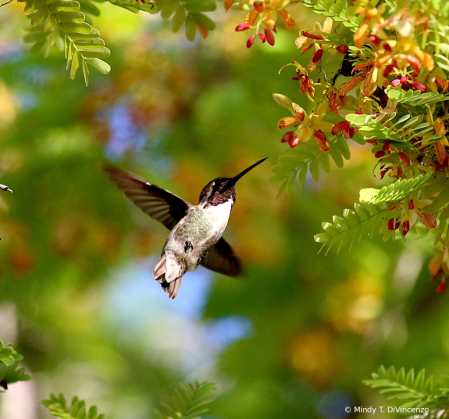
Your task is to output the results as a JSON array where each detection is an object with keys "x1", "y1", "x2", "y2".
[{"x1": 164, "y1": 201, "x2": 232, "y2": 271}]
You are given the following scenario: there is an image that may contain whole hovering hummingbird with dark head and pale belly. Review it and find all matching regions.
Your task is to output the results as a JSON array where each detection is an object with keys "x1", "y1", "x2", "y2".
[{"x1": 104, "y1": 158, "x2": 266, "y2": 299}]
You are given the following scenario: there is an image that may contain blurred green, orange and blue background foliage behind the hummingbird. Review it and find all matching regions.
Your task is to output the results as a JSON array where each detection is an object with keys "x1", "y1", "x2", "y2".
[{"x1": 0, "y1": 3, "x2": 449, "y2": 419}]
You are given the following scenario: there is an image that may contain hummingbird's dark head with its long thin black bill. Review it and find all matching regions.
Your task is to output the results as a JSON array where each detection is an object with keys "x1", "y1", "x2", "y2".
[{"x1": 199, "y1": 157, "x2": 267, "y2": 208}]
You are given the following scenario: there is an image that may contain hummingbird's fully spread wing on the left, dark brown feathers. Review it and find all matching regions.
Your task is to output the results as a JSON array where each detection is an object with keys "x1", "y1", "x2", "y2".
[{"x1": 103, "y1": 166, "x2": 190, "y2": 230}]
